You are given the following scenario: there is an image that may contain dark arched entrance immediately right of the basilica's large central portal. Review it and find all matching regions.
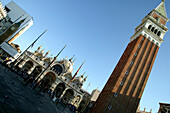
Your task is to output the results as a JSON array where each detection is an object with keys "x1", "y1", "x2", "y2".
[{"x1": 54, "y1": 83, "x2": 65, "y2": 98}]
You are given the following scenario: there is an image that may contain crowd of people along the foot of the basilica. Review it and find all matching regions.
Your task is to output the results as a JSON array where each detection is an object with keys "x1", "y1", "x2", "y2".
[{"x1": 0, "y1": 54, "x2": 76, "y2": 111}]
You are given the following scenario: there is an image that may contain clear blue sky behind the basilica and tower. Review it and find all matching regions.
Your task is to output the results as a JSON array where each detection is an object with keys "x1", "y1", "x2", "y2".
[{"x1": 2, "y1": 0, "x2": 170, "y2": 113}]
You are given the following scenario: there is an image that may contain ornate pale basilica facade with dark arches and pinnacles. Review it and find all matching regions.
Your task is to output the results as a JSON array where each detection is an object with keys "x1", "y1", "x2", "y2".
[{"x1": 14, "y1": 46, "x2": 87, "y2": 108}]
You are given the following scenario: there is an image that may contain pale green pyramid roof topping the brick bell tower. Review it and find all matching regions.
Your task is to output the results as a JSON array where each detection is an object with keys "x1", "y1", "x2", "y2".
[{"x1": 155, "y1": 0, "x2": 168, "y2": 18}]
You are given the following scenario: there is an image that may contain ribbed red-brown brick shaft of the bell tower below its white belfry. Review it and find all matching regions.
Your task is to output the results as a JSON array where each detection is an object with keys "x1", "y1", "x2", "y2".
[{"x1": 91, "y1": 35, "x2": 159, "y2": 113}]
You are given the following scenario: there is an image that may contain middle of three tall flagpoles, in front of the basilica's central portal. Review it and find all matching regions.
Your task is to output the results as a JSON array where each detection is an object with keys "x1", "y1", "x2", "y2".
[{"x1": 33, "y1": 45, "x2": 66, "y2": 89}]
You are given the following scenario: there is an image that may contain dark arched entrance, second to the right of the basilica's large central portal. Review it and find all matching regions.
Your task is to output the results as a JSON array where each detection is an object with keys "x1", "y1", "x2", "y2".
[{"x1": 62, "y1": 89, "x2": 74, "y2": 103}]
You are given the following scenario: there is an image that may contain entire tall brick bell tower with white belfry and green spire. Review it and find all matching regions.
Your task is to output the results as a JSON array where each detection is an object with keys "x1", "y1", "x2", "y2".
[{"x1": 91, "y1": 0, "x2": 169, "y2": 113}]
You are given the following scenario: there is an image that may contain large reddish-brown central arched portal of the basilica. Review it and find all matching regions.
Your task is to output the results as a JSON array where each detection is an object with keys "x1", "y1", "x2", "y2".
[{"x1": 41, "y1": 72, "x2": 56, "y2": 88}]
